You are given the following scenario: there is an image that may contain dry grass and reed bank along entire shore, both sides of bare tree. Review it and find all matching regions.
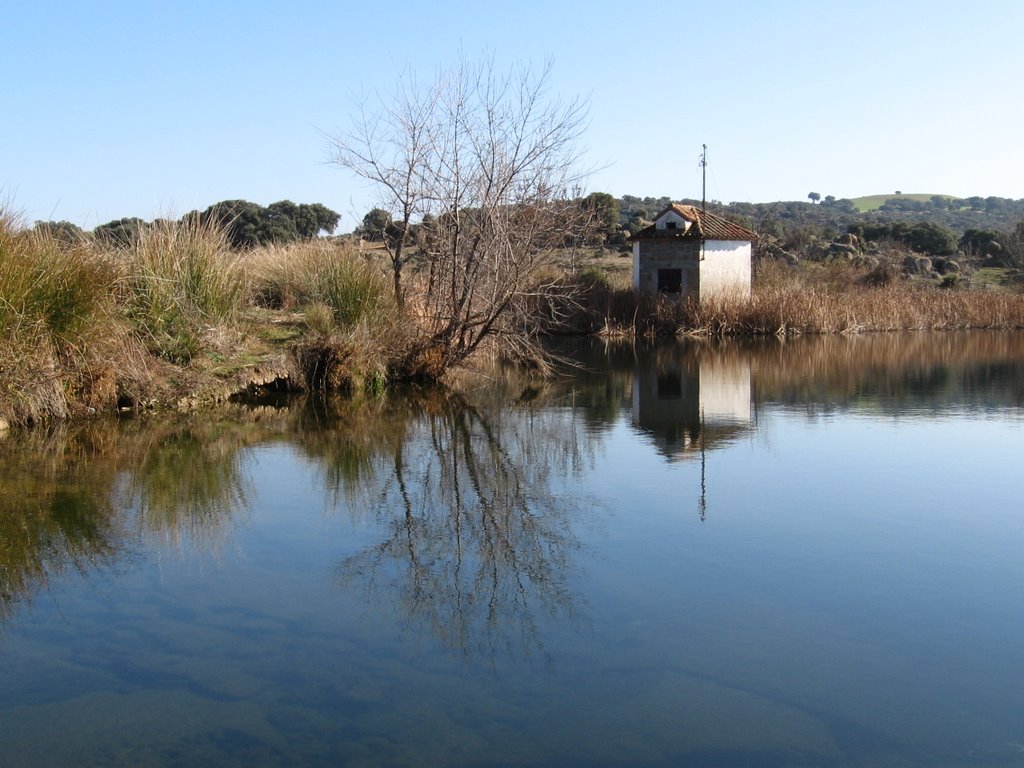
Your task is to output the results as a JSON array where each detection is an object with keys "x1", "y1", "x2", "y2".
[{"x1": 0, "y1": 212, "x2": 1024, "y2": 430}]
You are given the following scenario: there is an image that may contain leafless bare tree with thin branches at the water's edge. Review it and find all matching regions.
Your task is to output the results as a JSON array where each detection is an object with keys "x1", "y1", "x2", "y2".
[{"x1": 331, "y1": 60, "x2": 588, "y2": 376}]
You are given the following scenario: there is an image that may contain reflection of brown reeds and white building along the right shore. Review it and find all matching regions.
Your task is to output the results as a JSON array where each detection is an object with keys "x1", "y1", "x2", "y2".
[{"x1": 557, "y1": 332, "x2": 1024, "y2": 428}]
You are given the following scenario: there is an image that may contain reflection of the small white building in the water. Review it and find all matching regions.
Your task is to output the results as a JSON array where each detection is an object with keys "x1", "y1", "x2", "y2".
[{"x1": 633, "y1": 347, "x2": 754, "y2": 460}]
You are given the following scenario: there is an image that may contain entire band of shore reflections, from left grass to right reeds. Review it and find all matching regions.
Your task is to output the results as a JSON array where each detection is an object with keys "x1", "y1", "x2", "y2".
[{"x1": 0, "y1": 333, "x2": 1024, "y2": 638}]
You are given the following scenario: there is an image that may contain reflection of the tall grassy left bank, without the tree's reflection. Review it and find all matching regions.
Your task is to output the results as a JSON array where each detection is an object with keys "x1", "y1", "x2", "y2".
[{"x1": 0, "y1": 411, "x2": 282, "y2": 618}]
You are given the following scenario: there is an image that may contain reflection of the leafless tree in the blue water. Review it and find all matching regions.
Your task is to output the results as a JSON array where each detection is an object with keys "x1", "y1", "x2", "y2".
[{"x1": 340, "y1": 396, "x2": 593, "y2": 659}]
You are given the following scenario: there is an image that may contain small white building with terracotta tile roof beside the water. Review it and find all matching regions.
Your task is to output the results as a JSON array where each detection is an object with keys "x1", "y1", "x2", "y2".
[{"x1": 632, "y1": 203, "x2": 758, "y2": 301}]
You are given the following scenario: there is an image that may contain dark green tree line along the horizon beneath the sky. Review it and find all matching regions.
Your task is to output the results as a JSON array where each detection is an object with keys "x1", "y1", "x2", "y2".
[{"x1": 36, "y1": 191, "x2": 1024, "y2": 268}]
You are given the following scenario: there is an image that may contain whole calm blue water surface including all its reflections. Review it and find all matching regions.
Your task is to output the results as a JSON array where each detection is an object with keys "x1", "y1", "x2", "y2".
[{"x1": 0, "y1": 334, "x2": 1024, "y2": 766}]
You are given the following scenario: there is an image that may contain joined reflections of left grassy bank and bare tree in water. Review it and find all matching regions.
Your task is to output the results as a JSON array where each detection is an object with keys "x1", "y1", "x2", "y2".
[{"x1": 0, "y1": 390, "x2": 593, "y2": 658}]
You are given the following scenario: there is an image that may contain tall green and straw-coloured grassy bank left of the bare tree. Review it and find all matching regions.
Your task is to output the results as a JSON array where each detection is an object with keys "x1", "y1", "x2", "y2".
[{"x1": 0, "y1": 213, "x2": 407, "y2": 431}]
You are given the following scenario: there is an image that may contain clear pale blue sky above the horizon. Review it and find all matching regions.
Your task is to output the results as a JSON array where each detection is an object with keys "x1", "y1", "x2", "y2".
[{"x1": 0, "y1": 0, "x2": 1024, "y2": 231}]
